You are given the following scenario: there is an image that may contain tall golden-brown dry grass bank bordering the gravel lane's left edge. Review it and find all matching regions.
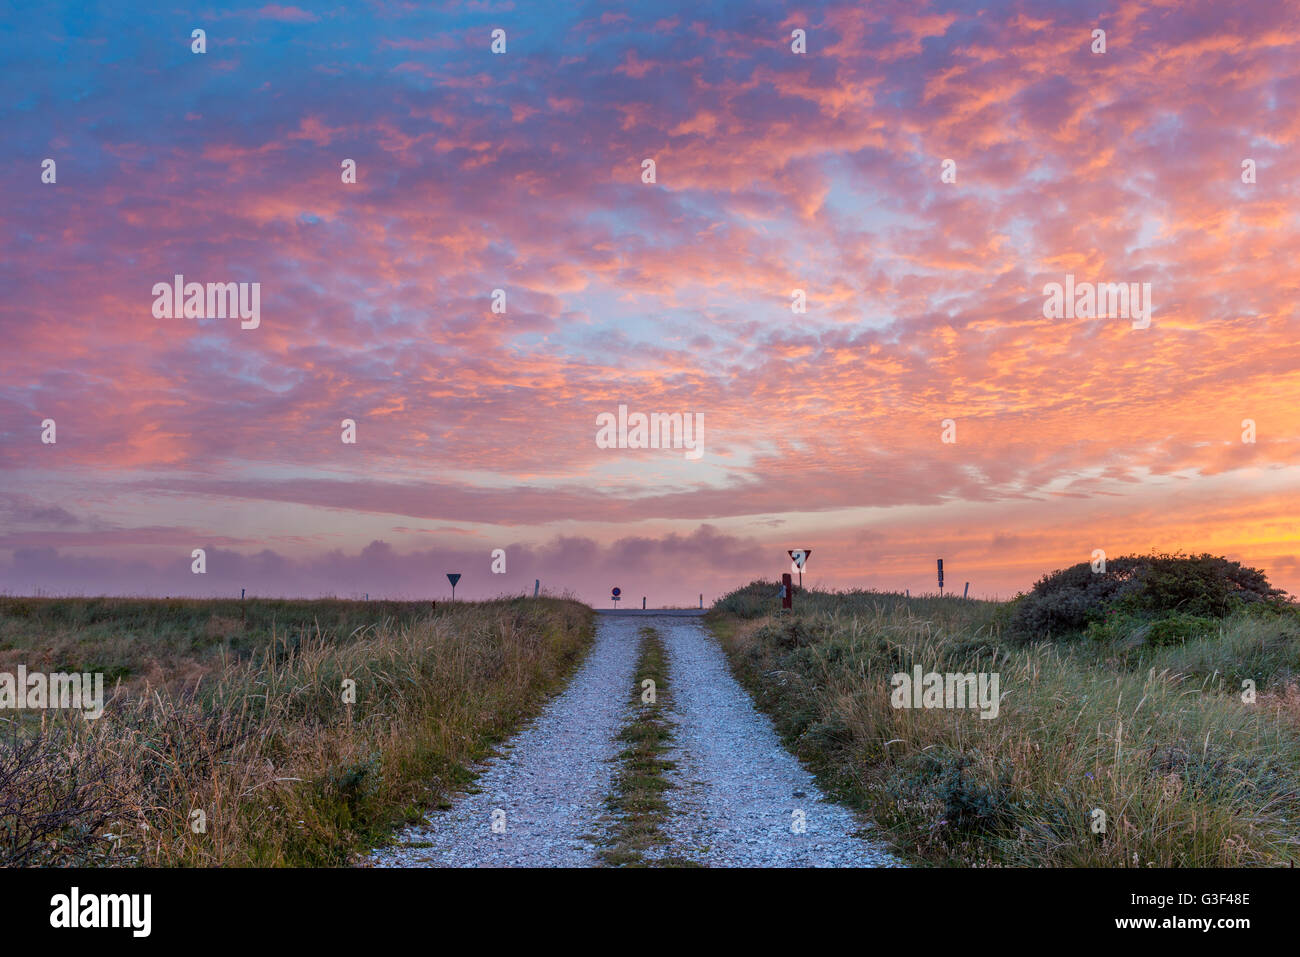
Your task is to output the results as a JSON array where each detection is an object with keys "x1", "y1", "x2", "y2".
[{"x1": 0, "y1": 598, "x2": 593, "y2": 866}]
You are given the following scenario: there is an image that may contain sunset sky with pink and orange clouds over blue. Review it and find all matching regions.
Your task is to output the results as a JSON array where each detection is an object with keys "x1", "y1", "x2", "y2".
[{"x1": 0, "y1": 0, "x2": 1300, "y2": 607}]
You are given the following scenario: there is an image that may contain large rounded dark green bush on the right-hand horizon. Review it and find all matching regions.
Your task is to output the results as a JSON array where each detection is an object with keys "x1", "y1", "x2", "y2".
[{"x1": 1009, "y1": 554, "x2": 1288, "y2": 644}]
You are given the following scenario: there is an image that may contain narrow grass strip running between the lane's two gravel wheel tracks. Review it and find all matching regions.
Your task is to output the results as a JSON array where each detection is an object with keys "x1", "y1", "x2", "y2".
[{"x1": 601, "y1": 628, "x2": 681, "y2": 867}]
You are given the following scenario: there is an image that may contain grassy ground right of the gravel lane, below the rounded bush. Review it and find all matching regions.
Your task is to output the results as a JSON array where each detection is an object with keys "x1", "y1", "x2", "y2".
[{"x1": 710, "y1": 585, "x2": 1300, "y2": 867}]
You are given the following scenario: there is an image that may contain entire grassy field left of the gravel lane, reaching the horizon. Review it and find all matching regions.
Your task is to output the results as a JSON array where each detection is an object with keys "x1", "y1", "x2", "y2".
[{"x1": 0, "y1": 598, "x2": 593, "y2": 866}]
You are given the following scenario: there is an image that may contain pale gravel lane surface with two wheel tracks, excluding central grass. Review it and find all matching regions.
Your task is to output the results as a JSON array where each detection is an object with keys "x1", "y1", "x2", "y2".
[{"x1": 371, "y1": 616, "x2": 898, "y2": 867}]
